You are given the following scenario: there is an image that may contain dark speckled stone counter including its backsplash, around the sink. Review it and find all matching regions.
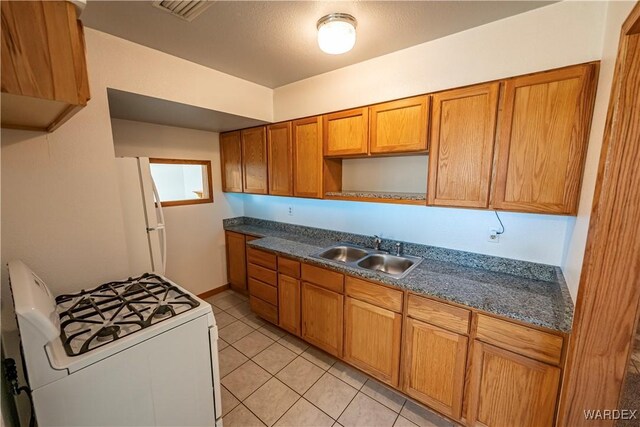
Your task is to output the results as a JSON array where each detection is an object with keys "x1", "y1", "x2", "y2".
[{"x1": 224, "y1": 217, "x2": 573, "y2": 333}]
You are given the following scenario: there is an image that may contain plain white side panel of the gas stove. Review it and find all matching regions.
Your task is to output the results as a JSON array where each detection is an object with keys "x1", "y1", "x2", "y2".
[{"x1": 33, "y1": 313, "x2": 220, "y2": 427}]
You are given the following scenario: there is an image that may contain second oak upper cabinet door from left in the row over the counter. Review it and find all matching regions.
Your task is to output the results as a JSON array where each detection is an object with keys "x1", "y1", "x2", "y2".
[{"x1": 240, "y1": 126, "x2": 268, "y2": 194}]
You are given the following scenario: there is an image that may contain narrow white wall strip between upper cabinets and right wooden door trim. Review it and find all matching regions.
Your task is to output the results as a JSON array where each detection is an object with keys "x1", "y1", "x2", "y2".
[{"x1": 562, "y1": 1, "x2": 635, "y2": 300}]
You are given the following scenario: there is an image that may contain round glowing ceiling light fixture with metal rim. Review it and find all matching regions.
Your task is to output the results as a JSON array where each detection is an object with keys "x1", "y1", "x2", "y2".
[{"x1": 317, "y1": 13, "x2": 357, "y2": 55}]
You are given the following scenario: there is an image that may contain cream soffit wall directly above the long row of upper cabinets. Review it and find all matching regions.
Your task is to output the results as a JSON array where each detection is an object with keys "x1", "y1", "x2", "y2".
[{"x1": 274, "y1": 1, "x2": 606, "y2": 121}]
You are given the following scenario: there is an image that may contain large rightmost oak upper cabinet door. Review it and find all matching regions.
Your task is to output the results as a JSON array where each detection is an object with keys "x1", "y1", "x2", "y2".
[{"x1": 493, "y1": 64, "x2": 597, "y2": 215}]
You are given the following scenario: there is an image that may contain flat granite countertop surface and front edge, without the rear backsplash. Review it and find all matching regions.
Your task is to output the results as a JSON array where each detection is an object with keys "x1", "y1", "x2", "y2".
[{"x1": 225, "y1": 224, "x2": 573, "y2": 333}]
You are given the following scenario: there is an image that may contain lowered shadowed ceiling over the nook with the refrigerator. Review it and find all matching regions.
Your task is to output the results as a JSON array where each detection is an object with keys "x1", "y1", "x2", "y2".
[{"x1": 107, "y1": 88, "x2": 266, "y2": 132}]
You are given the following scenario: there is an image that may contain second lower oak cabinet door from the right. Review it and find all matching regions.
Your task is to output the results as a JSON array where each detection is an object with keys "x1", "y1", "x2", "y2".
[{"x1": 403, "y1": 318, "x2": 468, "y2": 419}]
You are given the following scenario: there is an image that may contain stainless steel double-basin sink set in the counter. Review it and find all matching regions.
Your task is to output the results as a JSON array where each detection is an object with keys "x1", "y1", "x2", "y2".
[{"x1": 316, "y1": 243, "x2": 422, "y2": 279}]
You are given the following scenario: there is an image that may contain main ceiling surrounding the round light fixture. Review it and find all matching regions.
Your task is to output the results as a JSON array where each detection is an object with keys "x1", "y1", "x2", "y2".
[{"x1": 82, "y1": 0, "x2": 553, "y2": 88}]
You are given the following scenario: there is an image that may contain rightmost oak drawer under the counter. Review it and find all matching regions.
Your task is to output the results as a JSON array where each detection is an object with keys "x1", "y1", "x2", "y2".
[{"x1": 476, "y1": 314, "x2": 563, "y2": 365}]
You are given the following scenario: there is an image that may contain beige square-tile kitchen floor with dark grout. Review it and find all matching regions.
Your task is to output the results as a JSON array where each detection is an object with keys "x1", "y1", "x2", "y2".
[{"x1": 207, "y1": 291, "x2": 453, "y2": 427}]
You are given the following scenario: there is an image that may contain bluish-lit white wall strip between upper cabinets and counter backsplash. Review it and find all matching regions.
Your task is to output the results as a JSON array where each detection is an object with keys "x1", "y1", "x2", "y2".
[{"x1": 244, "y1": 195, "x2": 567, "y2": 265}]
